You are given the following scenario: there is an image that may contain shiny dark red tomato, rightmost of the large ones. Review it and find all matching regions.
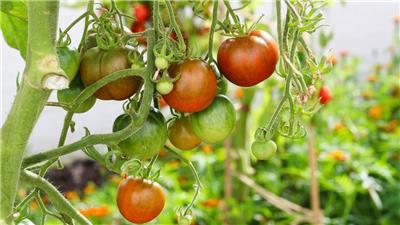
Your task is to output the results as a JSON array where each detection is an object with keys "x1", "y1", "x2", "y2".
[{"x1": 218, "y1": 30, "x2": 279, "y2": 87}]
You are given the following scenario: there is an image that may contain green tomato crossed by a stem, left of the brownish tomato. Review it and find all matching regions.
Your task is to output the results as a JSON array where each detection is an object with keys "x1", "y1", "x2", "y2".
[{"x1": 57, "y1": 76, "x2": 96, "y2": 113}]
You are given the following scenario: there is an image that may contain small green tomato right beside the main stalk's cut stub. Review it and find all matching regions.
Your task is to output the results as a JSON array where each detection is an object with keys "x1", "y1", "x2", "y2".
[{"x1": 57, "y1": 47, "x2": 80, "y2": 81}]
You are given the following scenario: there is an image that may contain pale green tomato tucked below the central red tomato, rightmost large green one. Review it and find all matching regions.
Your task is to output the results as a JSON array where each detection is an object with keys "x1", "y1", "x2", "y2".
[{"x1": 189, "y1": 95, "x2": 236, "y2": 144}]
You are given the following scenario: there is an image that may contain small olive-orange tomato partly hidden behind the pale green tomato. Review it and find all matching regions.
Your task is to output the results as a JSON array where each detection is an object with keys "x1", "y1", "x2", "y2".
[{"x1": 168, "y1": 117, "x2": 201, "y2": 150}]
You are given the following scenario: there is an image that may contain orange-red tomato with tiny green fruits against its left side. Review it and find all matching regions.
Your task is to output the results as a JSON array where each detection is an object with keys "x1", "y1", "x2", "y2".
[{"x1": 163, "y1": 59, "x2": 217, "y2": 113}]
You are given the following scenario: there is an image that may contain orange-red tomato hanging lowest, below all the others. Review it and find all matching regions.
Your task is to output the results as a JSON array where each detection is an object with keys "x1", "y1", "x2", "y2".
[{"x1": 117, "y1": 178, "x2": 165, "y2": 224}]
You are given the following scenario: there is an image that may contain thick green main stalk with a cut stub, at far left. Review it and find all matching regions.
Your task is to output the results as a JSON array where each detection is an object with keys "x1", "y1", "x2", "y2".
[{"x1": 0, "y1": 1, "x2": 61, "y2": 224}]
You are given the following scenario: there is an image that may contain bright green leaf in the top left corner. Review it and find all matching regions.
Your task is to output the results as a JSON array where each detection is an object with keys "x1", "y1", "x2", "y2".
[{"x1": 0, "y1": 1, "x2": 28, "y2": 59}]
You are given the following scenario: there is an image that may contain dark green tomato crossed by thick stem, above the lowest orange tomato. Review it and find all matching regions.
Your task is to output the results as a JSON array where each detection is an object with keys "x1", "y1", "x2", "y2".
[{"x1": 113, "y1": 109, "x2": 167, "y2": 160}]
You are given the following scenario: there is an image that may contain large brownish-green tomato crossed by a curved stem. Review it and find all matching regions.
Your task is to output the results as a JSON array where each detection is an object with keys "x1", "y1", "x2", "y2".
[{"x1": 80, "y1": 47, "x2": 141, "y2": 100}]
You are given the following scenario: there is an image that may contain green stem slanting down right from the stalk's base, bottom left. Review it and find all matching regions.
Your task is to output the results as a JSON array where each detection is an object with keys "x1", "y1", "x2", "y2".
[{"x1": 21, "y1": 170, "x2": 92, "y2": 225}]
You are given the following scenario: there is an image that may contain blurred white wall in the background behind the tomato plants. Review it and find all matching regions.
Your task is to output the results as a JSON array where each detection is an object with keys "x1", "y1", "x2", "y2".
[{"x1": 0, "y1": 1, "x2": 399, "y2": 157}]
